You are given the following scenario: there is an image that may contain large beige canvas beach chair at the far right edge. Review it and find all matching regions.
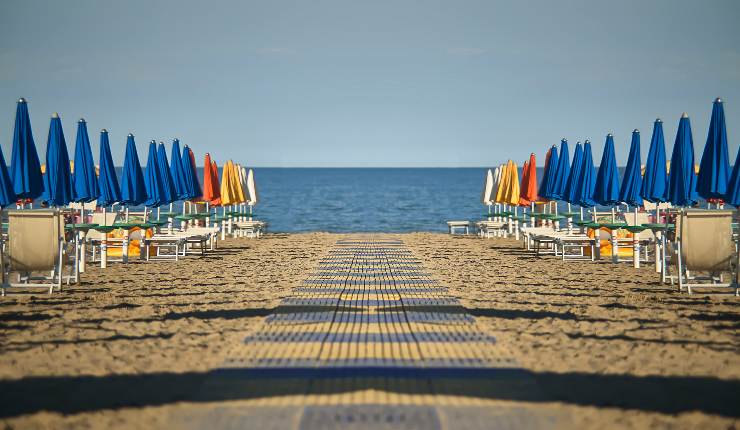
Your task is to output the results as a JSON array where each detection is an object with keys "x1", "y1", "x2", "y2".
[{"x1": 675, "y1": 210, "x2": 740, "y2": 296}]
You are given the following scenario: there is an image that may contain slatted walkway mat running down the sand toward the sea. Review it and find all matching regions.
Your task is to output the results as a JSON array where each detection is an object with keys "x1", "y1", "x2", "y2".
[{"x1": 182, "y1": 236, "x2": 566, "y2": 430}]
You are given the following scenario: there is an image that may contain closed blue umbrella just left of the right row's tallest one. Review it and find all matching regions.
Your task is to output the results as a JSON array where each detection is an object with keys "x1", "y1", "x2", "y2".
[{"x1": 668, "y1": 113, "x2": 697, "y2": 206}]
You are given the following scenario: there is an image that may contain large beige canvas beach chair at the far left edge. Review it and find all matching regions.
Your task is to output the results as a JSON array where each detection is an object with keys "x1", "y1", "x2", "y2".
[{"x1": 2, "y1": 210, "x2": 68, "y2": 296}]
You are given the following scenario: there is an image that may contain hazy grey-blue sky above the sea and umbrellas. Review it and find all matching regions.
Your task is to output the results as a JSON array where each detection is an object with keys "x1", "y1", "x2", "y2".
[{"x1": 0, "y1": 0, "x2": 740, "y2": 167}]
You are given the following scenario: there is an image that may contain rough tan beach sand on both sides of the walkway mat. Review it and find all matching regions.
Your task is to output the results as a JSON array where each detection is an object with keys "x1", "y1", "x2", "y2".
[{"x1": 0, "y1": 233, "x2": 740, "y2": 428}]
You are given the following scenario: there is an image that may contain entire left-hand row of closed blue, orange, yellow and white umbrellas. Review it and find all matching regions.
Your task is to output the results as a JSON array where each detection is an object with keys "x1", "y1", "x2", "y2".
[{"x1": 0, "y1": 99, "x2": 257, "y2": 207}]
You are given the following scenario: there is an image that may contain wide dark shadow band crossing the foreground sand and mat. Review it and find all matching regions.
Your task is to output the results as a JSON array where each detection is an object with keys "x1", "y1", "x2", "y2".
[{"x1": 0, "y1": 367, "x2": 740, "y2": 418}]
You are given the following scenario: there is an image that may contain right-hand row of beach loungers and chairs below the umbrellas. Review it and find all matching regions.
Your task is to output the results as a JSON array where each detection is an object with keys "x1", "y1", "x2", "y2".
[{"x1": 476, "y1": 209, "x2": 740, "y2": 295}]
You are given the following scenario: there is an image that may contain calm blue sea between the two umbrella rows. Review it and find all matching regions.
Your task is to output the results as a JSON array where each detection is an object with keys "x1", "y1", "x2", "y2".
[{"x1": 254, "y1": 168, "x2": 485, "y2": 232}]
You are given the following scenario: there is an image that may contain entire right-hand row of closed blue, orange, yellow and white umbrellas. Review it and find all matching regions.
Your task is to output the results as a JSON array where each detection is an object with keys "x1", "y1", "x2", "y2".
[{"x1": 481, "y1": 98, "x2": 740, "y2": 212}]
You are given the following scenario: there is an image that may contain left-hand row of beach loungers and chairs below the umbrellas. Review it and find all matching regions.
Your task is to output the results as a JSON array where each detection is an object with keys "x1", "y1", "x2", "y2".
[{"x1": 0, "y1": 210, "x2": 267, "y2": 296}]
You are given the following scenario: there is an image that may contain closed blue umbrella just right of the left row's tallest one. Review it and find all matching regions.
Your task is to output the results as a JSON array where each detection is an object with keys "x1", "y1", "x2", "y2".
[{"x1": 43, "y1": 113, "x2": 72, "y2": 206}]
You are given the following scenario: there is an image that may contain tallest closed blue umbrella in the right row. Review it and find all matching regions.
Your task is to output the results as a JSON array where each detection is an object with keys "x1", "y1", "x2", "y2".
[{"x1": 696, "y1": 99, "x2": 730, "y2": 200}]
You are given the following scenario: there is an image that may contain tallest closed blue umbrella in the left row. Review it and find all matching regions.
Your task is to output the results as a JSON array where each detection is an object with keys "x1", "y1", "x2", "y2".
[{"x1": 10, "y1": 99, "x2": 44, "y2": 199}]
